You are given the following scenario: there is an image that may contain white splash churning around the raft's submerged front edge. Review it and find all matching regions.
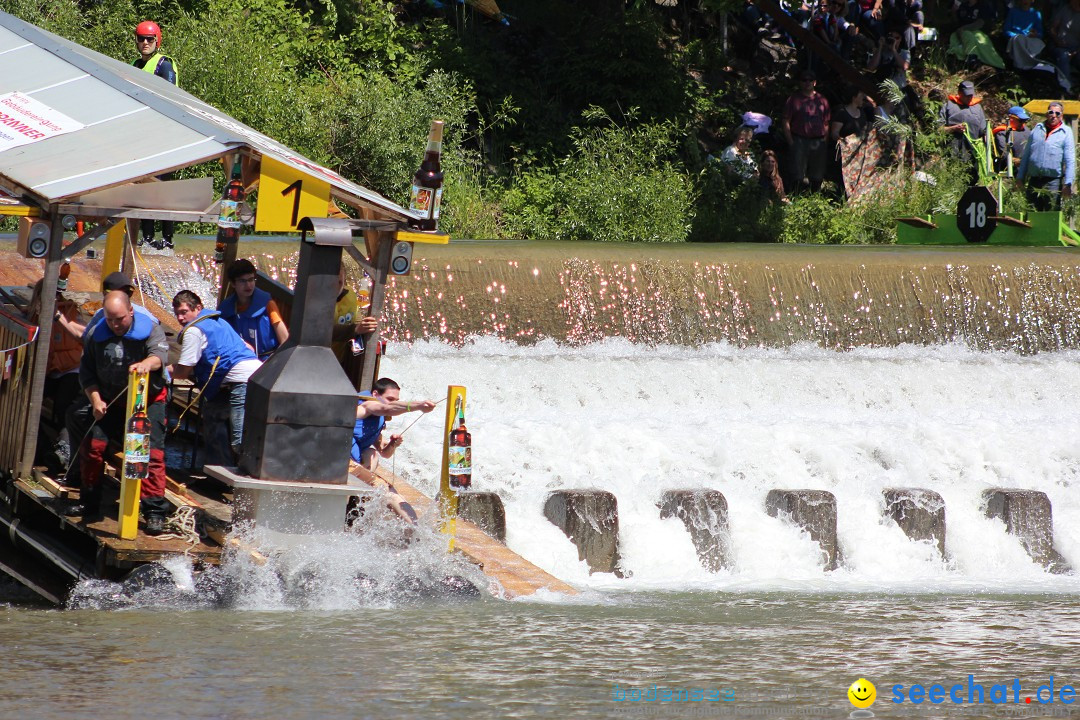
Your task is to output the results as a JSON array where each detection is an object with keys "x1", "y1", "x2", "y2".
[{"x1": 68, "y1": 503, "x2": 490, "y2": 611}]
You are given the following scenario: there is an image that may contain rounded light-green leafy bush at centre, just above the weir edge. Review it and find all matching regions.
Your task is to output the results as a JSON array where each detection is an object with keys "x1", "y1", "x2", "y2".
[{"x1": 503, "y1": 108, "x2": 694, "y2": 243}]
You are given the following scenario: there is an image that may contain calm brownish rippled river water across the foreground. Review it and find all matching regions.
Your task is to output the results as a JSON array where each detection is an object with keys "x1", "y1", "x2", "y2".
[{"x1": 0, "y1": 593, "x2": 1080, "y2": 719}]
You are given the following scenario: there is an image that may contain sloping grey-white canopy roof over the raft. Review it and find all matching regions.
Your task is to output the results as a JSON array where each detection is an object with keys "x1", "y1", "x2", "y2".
[{"x1": 0, "y1": 12, "x2": 418, "y2": 220}]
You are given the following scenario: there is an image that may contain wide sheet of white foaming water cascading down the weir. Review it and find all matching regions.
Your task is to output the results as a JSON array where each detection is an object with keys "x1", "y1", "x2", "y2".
[{"x1": 382, "y1": 338, "x2": 1080, "y2": 593}]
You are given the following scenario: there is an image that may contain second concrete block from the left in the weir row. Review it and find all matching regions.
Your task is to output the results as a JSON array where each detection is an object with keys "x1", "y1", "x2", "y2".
[{"x1": 543, "y1": 490, "x2": 623, "y2": 578}]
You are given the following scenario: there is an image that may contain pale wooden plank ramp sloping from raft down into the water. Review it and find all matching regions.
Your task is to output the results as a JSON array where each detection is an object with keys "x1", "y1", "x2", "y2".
[{"x1": 360, "y1": 462, "x2": 578, "y2": 598}]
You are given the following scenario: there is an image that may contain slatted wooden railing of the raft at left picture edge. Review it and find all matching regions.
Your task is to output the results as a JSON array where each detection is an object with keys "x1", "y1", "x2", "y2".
[{"x1": 0, "y1": 307, "x2": 38, "y2": 475}]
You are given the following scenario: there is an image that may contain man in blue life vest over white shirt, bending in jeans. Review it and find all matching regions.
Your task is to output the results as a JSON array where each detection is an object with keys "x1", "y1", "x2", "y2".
[{"x1": 168, "y1": 290, "x2": 262, "y2": 465}]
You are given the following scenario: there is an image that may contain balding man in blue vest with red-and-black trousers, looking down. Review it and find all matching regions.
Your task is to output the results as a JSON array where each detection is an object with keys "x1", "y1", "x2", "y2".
[{"x1": 65, "y1": 290, "x2": 171, "y2": 534}]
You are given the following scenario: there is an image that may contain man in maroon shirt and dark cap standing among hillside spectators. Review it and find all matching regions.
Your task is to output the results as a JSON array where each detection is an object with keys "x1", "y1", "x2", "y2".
[{"x1": 781, "y1": 70, "x2": 831, "y2": 192}]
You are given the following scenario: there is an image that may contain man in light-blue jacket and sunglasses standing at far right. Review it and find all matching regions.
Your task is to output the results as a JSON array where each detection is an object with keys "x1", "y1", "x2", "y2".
[{"x1": 1016, "y1": 101, "x2": 1077, "y2": 210}]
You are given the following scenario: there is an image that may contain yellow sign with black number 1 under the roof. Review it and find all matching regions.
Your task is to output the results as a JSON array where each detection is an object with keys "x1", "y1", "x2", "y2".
[{"x1": 255, "y1": 155, "x2": 330, "y2": 232}]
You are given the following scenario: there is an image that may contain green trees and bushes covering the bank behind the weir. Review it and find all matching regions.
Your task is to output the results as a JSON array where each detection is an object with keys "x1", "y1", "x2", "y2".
[{"x1": 0, "y1": 0, "x2": 1062, "y2": 243}]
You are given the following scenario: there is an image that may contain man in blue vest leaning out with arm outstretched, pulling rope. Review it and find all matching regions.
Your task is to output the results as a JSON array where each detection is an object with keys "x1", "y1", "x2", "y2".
[{"x1": 349, "y1": 378, "x2": 435, "y2": 522}]
